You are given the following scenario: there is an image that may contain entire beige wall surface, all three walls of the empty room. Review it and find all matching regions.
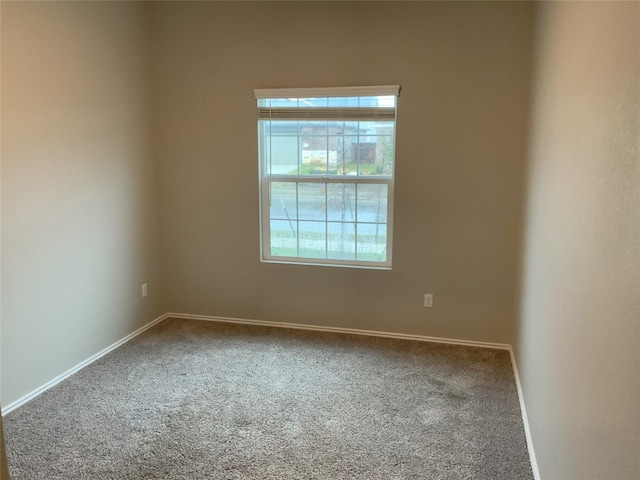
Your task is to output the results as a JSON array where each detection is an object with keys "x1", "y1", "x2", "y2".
[{"x1": 0, "y1": 2, "x2": 640, "y2": 479}]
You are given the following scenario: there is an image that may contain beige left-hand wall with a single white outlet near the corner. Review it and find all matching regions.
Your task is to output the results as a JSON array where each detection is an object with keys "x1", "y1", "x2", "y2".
[{"x1": 1, "y1": 2, "x2": 166, "y2": 406}]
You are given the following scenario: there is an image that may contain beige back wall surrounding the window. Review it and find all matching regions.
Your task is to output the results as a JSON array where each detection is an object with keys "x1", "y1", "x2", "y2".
[{"x1": 152, "y1": 2, "x2": 533, "y2": 342}]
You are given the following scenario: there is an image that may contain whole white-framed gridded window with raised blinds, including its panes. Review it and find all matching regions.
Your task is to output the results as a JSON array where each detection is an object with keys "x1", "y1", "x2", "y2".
[{"x1": 255, "y1": 85, "x2": 400, "y2": 269}]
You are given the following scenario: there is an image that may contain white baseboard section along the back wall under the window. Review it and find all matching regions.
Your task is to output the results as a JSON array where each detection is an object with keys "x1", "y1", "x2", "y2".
[{"x1": 165, "y1": 313, "x2": 511, "y2": 350}]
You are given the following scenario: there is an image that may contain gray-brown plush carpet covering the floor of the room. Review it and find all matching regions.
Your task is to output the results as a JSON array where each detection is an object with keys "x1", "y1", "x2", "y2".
[{"x1": 5, "y1": 319, "x2": 533, "y2": 480}]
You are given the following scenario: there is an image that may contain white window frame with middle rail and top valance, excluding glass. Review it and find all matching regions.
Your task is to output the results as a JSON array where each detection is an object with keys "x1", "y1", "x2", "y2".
[{"x1": 254, "y1": 85, "x2": 400, "y2": 270}]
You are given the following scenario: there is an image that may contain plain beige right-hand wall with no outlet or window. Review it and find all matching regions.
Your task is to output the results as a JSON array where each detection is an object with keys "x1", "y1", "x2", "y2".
[{"x1": 514, "y1": 2, "x2": 640, "y2": 480}]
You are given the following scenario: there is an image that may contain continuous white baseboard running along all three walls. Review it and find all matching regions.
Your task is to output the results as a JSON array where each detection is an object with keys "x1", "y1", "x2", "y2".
[{"x1": 2, "y1": 313, "x2": 541, "y2": 480}]
